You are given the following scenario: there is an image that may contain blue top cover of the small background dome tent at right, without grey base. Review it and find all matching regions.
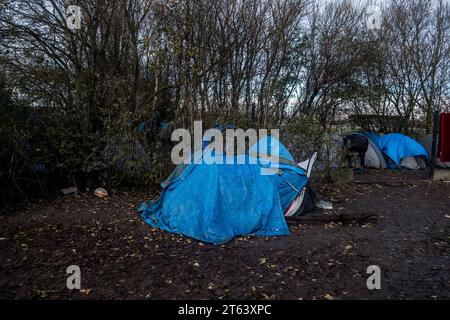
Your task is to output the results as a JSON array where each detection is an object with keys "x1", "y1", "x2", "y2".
[{"x1": 378, "y1": 133, "x2": 428, "y2": 165}]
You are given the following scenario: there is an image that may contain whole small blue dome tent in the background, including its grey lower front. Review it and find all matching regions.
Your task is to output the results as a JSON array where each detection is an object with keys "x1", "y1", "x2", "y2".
[{"x1": 378, "y1": 133, "x2": 428, "y2": 170}]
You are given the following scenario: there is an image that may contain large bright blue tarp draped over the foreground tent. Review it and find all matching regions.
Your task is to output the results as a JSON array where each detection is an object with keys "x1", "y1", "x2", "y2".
[{"x1": 140, "y1": 138, "x2": 308, "y2": 244}]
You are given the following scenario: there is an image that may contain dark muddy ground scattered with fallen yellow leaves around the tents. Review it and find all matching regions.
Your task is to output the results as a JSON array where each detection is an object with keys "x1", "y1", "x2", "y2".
[{"x1": 0, "y1": 171, "x2": 450, "y2": 299}]
